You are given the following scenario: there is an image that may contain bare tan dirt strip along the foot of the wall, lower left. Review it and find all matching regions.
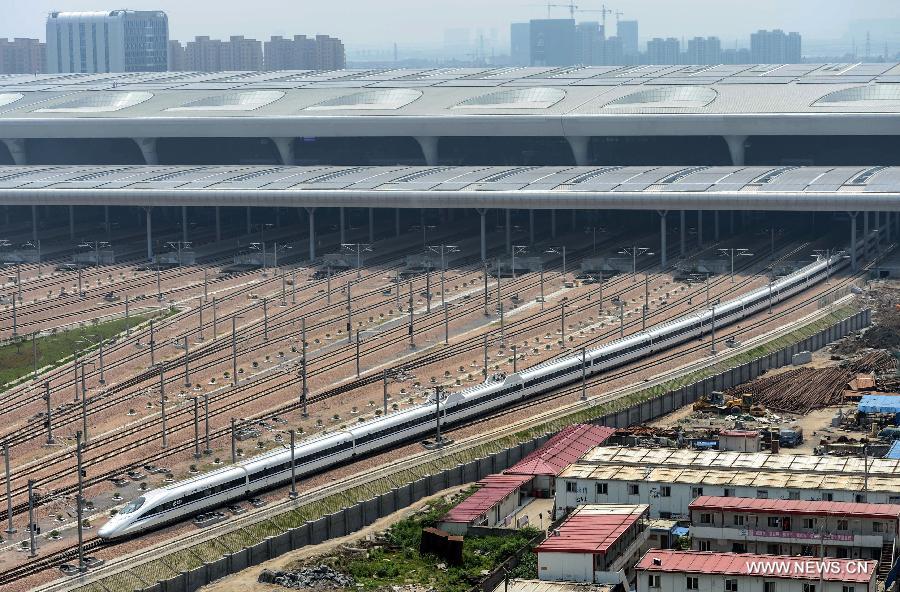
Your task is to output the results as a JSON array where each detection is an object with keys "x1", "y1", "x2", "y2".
[{"x1": 200, "y1": 484, "x2": 470, "y2": 592}]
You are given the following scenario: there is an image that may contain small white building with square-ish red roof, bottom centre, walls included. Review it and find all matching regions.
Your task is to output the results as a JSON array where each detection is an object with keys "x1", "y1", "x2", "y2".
[{"x1": 535, "y1": 504, "x2": 650, "y2": 583}]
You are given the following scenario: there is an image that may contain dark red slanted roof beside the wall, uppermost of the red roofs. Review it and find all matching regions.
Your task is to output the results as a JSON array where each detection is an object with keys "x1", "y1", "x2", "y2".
[{"x1": 504, "y1": 424, "x2": 616, "y2": 477}]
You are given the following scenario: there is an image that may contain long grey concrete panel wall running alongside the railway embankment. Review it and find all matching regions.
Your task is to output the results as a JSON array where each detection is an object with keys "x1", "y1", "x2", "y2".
[{"x1": 141, "y1": 309, "x2": 871, "y2": 592}]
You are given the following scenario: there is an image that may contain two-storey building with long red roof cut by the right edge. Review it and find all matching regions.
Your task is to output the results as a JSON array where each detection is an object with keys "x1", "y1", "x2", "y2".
[{"x1": 688, "y1": 496, "x2": 900, "y2": 567}]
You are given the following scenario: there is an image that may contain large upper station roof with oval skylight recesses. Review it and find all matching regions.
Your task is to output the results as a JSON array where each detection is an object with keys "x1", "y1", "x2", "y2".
[{"x1": 0, "y1": 63, "x2": 900, "y2": 138}]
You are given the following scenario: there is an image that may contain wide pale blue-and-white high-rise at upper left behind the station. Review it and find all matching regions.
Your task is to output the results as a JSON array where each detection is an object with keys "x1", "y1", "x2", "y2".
[{"x1": 47, "y1": 10, "x2": 169, "y2": 73}]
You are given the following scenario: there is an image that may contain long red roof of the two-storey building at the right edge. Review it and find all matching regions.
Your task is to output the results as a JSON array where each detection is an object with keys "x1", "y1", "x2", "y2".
[{"x1": 688, "y1": 495, "x2": 900, "y2": 520}]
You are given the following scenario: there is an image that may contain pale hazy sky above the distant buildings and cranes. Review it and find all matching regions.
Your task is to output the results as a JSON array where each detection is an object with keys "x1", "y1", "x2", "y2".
[{"x1": 0, "y1": 0, "x2": 900, "y2": 47}]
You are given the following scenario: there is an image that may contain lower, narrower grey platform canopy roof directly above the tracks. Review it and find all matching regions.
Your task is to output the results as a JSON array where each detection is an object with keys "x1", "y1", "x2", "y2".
[{"x1": 0, "y1": 165, "x2": 900, "y2": 212}]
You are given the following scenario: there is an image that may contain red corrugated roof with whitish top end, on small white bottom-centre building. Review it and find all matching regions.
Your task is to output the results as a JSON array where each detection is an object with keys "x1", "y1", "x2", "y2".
[{"x1": 535, "y1": 504, "x2": 650, "y2": 555}]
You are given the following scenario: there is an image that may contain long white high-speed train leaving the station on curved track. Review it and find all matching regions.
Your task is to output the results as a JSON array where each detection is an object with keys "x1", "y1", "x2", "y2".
[{"x1": 98, "y1": 252, "x2": 846, "y2": 538}]
